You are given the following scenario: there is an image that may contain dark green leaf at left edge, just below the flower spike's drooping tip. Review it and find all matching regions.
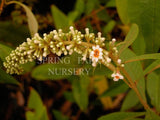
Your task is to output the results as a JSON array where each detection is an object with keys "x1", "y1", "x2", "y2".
[{"x1": 0, "y1": 68, "x2": 19, "y2": 85}]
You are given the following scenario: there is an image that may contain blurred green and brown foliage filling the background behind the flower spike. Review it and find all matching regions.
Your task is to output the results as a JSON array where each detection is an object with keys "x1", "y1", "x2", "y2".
[{"x1": 0, "y1": 0, "x2": 160, "y2": 120}]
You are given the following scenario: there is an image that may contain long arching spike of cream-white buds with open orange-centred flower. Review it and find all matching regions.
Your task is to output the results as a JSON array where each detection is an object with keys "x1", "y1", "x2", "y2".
[{"x1": 4, "y1": 26, "x2": 123, "y2": 80}]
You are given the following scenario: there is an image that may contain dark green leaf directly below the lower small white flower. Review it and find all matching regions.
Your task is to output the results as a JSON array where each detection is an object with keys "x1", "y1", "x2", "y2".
[{"x1": 100, "y1": 81, "x2": 129, "y2": 97}]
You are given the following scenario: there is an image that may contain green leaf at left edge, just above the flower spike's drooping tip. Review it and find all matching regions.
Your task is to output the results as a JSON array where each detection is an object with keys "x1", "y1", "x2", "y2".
[{"x1": 0, "y1": 44, "x2": 12, "y2": 61}]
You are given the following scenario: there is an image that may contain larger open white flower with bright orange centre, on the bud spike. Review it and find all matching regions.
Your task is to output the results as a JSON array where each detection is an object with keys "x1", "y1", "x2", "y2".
[{"x1": 90, "y1": 45, "x2": 103, "y2": 65}]
